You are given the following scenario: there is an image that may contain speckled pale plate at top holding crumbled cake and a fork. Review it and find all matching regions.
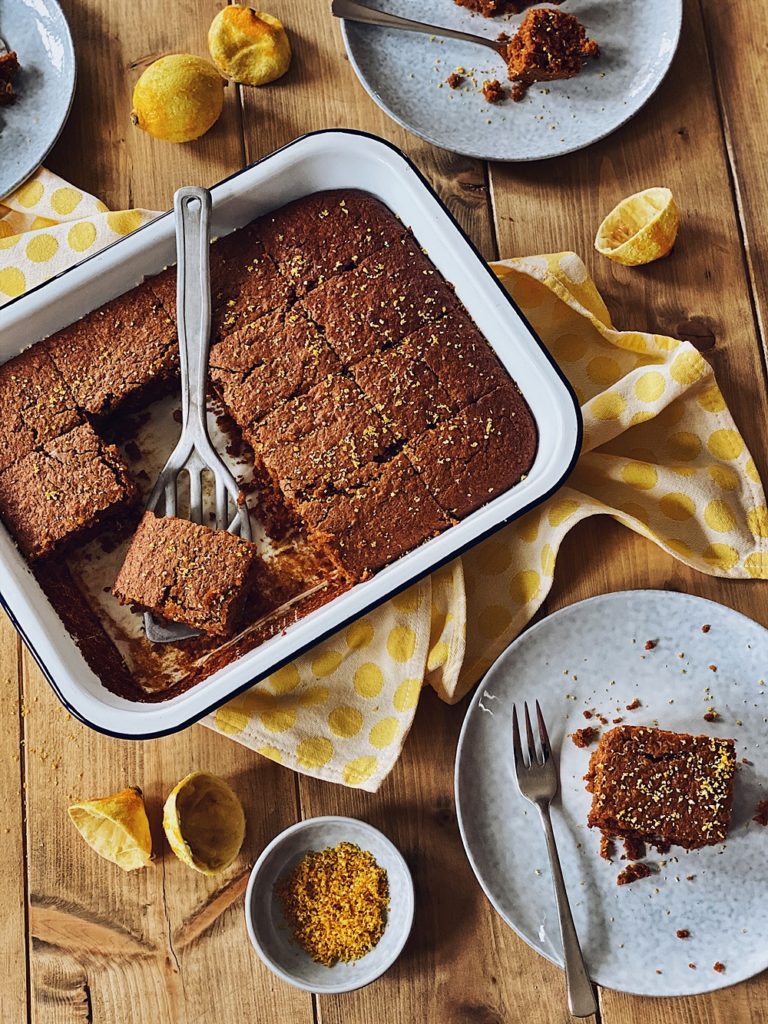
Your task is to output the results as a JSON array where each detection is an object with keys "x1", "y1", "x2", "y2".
[{"x1": 343, "y1": 0, "x2": 682, "y2": 160}]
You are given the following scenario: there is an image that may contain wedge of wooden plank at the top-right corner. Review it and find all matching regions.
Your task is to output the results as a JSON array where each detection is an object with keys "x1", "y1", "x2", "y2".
[{"x1": 701, "y1": 0, "x2": 768, "y2": 347}]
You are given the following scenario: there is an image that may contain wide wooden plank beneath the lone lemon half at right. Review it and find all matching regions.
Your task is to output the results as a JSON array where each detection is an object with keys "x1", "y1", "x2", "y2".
[{"x1": 492, "y1": 0, "x2": 768, "y2": 1024}]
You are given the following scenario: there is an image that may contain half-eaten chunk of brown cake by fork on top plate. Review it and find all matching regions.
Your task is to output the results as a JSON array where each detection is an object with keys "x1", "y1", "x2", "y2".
[{"x1": 507, "y1": 7, "x2": 600, "y2": 100}]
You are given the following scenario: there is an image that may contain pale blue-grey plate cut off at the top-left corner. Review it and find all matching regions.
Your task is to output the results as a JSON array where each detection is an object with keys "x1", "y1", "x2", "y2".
[{"x1": 0, "y1": 0, "x2": 75, "y2": 199}]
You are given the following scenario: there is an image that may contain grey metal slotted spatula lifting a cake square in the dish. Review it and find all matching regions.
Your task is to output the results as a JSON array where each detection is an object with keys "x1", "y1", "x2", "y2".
[{"x1": 144, "y1": 187, "x2": 251, "y2": 643}]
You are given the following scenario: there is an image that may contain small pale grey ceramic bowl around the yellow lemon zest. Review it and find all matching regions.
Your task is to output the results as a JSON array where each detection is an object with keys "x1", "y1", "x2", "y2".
[{"x1": 246, "y1": 815, "x2": 414, "y2": 994}]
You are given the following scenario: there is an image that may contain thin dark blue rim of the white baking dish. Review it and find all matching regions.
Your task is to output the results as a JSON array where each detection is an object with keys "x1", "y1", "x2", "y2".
[{"x1": 0, "y1": 128, "x2": 584, "y2": 740}]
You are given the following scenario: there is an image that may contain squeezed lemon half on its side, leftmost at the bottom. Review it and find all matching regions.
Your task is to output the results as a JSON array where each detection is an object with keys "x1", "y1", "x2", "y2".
[{"x1": 69, "y1": 785, "x2": 152, "y2": 871}]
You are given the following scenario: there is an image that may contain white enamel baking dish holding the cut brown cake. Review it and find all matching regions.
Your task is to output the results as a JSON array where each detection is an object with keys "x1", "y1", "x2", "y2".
[{"x1": 0, "y1": 130, "x2": 582, "y2": 739}]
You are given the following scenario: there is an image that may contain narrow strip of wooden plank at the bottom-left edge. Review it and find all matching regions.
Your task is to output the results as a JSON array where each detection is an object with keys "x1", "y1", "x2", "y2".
[{"x1": 0, "y1": 612, "x2": 28, "y2": 1021}]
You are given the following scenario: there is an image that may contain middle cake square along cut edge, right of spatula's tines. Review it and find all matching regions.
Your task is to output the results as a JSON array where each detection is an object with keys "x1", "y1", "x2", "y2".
[{"x1": 245, "y1": 375, "x2": 395, "y2": 500}]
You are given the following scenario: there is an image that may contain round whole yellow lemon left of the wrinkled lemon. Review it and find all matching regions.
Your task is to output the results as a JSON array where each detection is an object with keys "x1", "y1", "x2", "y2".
[{"x1": 131, "y1": 53, "x2": 224, "y2": 142}]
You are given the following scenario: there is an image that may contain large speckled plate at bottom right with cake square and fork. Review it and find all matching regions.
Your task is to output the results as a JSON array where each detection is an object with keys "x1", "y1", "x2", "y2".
[{"x1": 456, "y1": 591, "x2": 768, "y2": 995}]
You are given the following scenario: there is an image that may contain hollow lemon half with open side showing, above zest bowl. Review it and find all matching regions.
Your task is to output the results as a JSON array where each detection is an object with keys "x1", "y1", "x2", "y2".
[{"x1": 163, "y1": 771, "x2": 246, "y2": 874}]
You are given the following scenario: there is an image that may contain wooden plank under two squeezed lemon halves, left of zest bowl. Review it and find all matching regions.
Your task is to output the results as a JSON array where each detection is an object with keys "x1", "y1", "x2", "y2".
[{"x1": 21, "y1": 656, "x2": 311, "y2": 1024}]
